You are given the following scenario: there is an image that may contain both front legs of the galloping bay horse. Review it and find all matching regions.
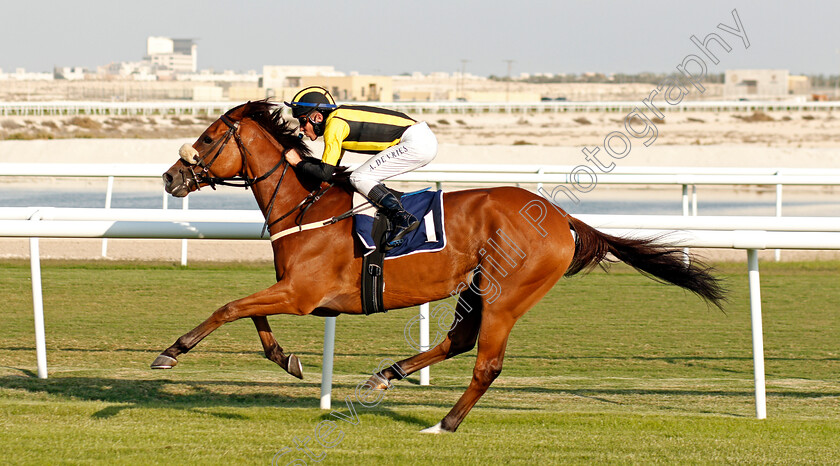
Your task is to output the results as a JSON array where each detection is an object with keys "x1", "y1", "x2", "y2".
[{"x1": 152, "y1": 283, "x2": 314, "y2": 377}]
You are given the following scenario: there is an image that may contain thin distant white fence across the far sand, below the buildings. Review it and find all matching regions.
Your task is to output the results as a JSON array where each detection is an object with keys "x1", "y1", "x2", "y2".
[{"x1": 0, "y1": 100, "x2": 840, "y2": 116}]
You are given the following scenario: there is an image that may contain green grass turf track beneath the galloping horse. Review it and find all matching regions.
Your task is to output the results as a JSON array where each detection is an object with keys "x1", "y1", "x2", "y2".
[{"x1": 0, "y1": 262, "x2": 840, "y2": 464}]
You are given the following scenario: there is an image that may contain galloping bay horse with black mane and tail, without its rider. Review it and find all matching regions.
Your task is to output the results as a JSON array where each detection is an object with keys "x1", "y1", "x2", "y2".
[{"x1": 161, "y1": 99, "x2": 725, "y2": 432}]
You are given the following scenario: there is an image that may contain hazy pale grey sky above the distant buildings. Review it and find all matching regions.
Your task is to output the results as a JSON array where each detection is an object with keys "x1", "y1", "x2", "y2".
[{"x1": 0, "y1": 0, "x2": 840, "y2": 76}]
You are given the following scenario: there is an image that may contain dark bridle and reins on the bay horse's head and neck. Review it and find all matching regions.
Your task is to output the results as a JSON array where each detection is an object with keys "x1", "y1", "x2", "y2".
[{"x1": 182, "y1": 115, "x2": 333, "y2": 237}]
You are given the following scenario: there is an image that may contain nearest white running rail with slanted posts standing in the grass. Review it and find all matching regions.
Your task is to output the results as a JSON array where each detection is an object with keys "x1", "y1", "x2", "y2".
[{"x1": 0, "y1": 208, "x2": 840, "y2": 419}]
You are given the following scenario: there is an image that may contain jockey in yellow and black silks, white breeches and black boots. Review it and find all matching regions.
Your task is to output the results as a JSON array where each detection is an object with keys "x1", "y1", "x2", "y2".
[{"x1": 284, "y1": 86, "x2": 437, "y2": 247}]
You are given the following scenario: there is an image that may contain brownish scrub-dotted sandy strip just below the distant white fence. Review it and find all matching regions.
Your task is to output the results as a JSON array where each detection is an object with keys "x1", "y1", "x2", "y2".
[{"x1": 0, "y1": 109, "x2": 840, "y2": 149}]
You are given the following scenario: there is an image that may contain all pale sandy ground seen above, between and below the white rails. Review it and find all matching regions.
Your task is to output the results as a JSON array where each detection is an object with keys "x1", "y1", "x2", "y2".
[{"x1": 0, "y1": 112, "x2": 840, "y2": 262}]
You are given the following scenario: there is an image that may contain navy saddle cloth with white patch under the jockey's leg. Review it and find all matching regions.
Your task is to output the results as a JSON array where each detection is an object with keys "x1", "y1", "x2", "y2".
[{"x1": 353, "y1": 190, "x2": 446, "y2": 259}]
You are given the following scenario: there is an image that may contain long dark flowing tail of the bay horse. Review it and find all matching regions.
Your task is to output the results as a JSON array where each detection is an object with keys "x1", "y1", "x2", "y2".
[{"x1": 565, "y1": 215, "x2": 726, "y2": 309}]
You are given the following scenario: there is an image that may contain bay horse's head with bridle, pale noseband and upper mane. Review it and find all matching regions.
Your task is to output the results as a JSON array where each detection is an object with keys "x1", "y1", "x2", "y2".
[{"x1": 163, "y1": 100, "x2": 309, "y2": 197}]
